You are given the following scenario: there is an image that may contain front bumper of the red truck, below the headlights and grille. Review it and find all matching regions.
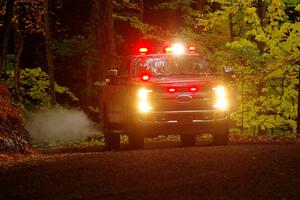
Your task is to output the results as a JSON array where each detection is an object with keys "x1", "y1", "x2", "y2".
[{"x1": 136, "y1": 110, "x2": 228, "y2": 136}]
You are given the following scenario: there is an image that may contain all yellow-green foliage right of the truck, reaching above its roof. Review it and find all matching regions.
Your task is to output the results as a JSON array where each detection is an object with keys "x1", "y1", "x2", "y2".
[{"x1": 171, "y1": 0, "x2": 300, "y2": 134}]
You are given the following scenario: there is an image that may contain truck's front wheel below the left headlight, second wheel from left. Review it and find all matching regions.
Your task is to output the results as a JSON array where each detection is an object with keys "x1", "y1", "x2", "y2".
[{"x1": 128, "y1": 126, "x2": 144, "y2": 149}]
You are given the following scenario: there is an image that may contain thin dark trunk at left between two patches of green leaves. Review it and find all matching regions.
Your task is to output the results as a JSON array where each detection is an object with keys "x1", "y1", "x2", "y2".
[{"x1": 14, "y1": 32, "x2": 24, "y2": 103}]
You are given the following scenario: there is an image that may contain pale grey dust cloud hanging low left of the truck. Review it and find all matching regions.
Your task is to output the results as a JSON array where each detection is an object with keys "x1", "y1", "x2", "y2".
[{"x1": 25, "y1": 108, "x2": 97, "y2": 144}]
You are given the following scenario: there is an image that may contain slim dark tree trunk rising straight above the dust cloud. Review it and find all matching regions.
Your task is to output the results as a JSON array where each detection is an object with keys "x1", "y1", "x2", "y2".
[{"x1": 44, "y1": 0, "x2": 56, "y2": 107}]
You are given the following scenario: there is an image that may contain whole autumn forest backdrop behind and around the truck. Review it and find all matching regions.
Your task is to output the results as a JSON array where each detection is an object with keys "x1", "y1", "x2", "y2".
[{"x1": 0, "y1": 0, "x2": 300, "y2": 150}]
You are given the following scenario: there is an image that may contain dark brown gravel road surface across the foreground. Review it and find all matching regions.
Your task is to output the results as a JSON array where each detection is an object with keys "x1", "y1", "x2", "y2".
[{"x1": 0, "y1": 144, "x2": 300, "y2": 200}]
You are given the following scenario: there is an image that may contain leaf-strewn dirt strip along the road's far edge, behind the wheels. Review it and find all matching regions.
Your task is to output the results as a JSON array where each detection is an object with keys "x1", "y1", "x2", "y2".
[{"x1": 0, "y1": 135, "x2": 300, "y2": 167}]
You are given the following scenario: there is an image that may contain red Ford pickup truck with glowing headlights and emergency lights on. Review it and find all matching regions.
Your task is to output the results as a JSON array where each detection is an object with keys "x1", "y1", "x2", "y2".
[{"x1": 99, "y1": 44, "x2": 231, "y2": 149}]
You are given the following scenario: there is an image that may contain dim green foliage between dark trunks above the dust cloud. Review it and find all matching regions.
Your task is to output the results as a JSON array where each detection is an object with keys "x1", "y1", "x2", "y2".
[{"x1": 7, "y1": 67, "x2": 78, "y2": 109}]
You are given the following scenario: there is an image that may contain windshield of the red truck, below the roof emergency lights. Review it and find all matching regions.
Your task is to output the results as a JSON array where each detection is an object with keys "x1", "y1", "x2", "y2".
[{"x1": 132, "y1": 55, "x2": 213, "y2": 76}]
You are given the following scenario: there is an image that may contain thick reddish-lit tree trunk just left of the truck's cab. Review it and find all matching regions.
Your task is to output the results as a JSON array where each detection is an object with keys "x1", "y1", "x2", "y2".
[{"x1": 84, "y1": 0, "x2": 117, "y2": 105}]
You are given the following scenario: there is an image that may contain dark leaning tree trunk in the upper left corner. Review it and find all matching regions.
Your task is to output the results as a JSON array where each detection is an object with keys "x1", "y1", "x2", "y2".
[{"x1": 0, "y1": 0, "x2": 15, "y2": 81}]
